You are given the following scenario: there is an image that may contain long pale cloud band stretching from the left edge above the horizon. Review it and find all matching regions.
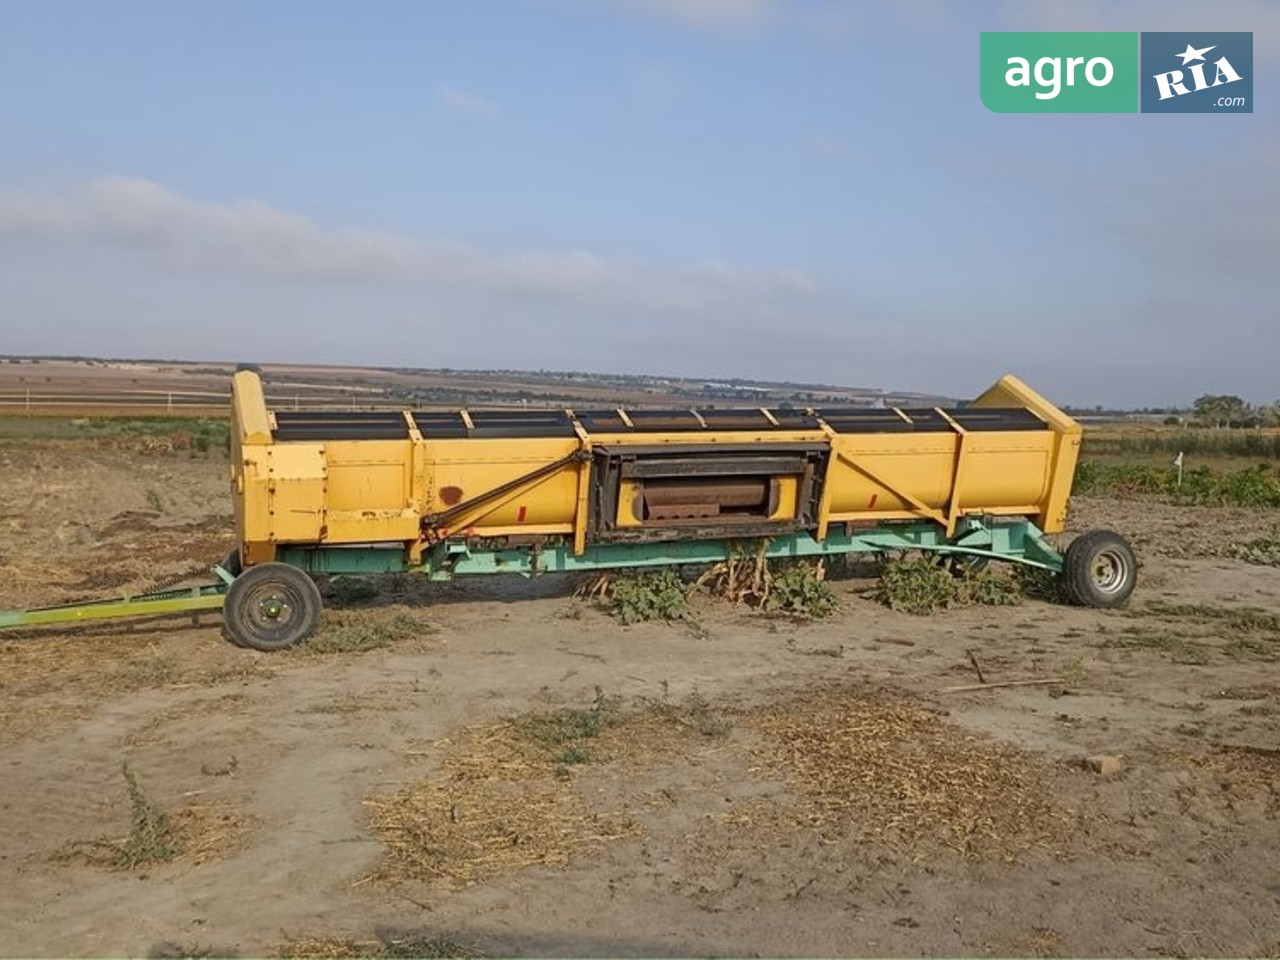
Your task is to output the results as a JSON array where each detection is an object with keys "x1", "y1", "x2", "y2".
[{"x1": 0, "y1": 177, "x2": 819, "y2": 316}]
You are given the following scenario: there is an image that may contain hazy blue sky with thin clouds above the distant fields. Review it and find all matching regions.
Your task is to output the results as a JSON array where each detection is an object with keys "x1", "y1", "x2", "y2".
[{"x1": 0, "y1": 0, "x2": 1280, "y2": 407}]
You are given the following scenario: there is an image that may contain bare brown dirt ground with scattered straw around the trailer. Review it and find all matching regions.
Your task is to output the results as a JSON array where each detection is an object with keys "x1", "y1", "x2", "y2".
[{"x1": 0, "y1": 442, "x2": 1280, "y2": 956}]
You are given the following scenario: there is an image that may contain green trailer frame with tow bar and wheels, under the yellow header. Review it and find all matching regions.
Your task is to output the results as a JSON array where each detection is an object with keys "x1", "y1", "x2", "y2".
[{"x1": 0, "y1": 517, "x2": 1137, "y2": 650}]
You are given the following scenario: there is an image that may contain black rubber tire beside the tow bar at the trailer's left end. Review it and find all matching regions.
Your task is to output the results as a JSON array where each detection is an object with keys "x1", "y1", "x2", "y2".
[{"x1": 223, "y1": 563, "x2": 324, "y2": 653}]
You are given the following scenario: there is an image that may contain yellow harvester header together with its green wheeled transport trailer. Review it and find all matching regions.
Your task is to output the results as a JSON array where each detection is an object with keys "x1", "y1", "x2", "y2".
[{"x1": 0, "y1": 370, "x2": 1137, "y2": 650}]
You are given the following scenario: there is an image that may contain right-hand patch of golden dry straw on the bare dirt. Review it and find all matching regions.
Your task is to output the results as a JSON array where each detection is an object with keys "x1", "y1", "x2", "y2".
[{"x1": 753, "y1": 690, "x2": 1073, "y2": 859}]
